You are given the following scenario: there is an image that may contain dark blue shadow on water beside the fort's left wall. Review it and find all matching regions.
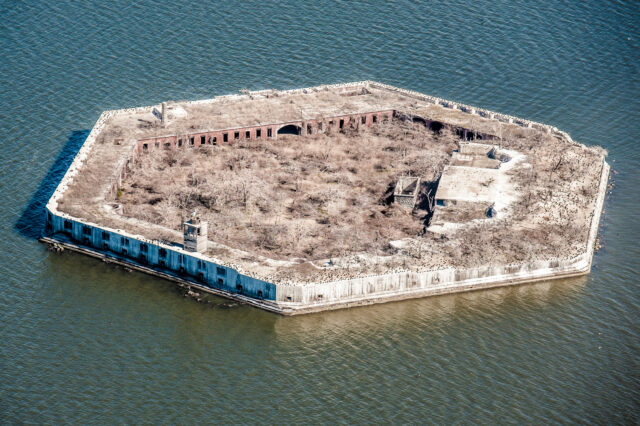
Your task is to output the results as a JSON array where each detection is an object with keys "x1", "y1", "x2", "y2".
[{"x1": 14, "y1": 130, "x2": 90, "y2": 239}]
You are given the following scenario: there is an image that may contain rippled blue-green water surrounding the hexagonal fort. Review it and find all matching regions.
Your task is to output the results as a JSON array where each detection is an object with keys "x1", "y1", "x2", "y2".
[{"x1": 0, "y1": 0, "x2": 640, "y2": 424}]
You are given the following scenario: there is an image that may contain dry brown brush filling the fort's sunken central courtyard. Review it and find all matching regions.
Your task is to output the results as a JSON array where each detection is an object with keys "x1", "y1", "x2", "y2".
[{"x1": 120, "y1": 121, "x2": 456, "y2": 259}]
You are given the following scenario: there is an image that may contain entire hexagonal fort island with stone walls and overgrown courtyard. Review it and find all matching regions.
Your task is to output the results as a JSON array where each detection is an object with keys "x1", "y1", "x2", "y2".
[{"x1": 41, "y1": 81, "x2": 609, "y2": 315}]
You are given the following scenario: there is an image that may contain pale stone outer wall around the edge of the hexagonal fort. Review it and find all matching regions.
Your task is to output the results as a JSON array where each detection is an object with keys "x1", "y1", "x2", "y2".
[{"x1": 43, "y1": 81, "x2": 609, "y2": 315}]
